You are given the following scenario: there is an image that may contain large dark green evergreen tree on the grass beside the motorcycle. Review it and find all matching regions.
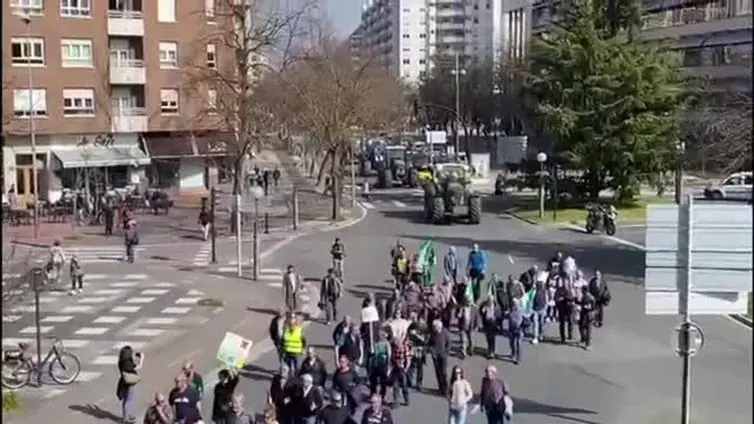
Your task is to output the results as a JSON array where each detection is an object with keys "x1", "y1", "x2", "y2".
[{"x1": 526, "y1": 0, "x2": 685, "y2": 200}]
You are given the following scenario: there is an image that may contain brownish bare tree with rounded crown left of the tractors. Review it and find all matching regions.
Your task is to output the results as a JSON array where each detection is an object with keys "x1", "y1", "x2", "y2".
[{"x1": 274, "y1": 36, "x2": 408, "y2": 219}]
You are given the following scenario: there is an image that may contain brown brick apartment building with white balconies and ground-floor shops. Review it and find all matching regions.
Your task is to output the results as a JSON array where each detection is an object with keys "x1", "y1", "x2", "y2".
[{"x1": 2, "y1": 0, "x2": 239, "y2": 205}]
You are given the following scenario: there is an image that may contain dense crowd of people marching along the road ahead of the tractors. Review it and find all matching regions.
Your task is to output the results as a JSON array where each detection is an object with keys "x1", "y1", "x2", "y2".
[{"x1": 256, "y1": 240, "x2": 611, "y2": 424}]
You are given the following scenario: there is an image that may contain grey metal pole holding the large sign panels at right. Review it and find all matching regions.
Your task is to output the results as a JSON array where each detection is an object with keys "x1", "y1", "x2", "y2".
[{"x1": 678, "y1": 196, "x2": 695, "y2": 424}]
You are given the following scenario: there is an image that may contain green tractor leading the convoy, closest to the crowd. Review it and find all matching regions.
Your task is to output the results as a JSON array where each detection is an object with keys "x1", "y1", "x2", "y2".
[{"x1": 424, "y1": 164, "x2": 482, "y2": 225}]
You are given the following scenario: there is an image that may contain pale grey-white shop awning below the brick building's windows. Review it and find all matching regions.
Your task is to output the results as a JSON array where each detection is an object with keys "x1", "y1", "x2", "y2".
[{"x1": 52, "y1": 146, "x2": 150, "y2": 168}]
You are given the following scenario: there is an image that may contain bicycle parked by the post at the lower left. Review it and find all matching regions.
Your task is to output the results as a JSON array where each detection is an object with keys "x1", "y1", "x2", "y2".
[{"x1": 2, "y1": 336, "x2": 81, "y2": 390}]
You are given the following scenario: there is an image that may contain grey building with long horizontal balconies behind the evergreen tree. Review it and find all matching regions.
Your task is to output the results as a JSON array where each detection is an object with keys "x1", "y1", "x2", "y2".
[{"x1": 532, "y1": 0, "x2": 752, "y2": 92}]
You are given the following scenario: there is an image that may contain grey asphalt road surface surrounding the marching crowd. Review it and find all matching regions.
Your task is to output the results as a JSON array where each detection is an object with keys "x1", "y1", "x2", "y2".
[{"x1": 231, "y1": 194, "x2": 752, "y2": 424}]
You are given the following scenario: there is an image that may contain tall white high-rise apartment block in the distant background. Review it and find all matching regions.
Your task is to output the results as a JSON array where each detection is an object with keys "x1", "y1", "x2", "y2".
[{"x1": 352, "y1": 0, "x2": 529, "y2": 83}]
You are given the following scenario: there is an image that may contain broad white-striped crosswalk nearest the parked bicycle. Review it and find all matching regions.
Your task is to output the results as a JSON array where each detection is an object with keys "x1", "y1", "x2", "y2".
[{"x1": 2, "y1": 274, "x2": 211, "y2": 399}]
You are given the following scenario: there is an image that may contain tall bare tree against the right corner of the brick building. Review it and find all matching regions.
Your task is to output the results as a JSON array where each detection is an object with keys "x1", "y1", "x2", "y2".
[{"x1": 182, "y1": 0, "x2": 308, "y2": 194}]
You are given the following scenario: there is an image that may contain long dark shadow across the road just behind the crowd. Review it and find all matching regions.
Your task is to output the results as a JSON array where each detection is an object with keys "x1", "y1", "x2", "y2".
[{"x1": 400, "y1": 234, "x2": 644, "y2": 285}]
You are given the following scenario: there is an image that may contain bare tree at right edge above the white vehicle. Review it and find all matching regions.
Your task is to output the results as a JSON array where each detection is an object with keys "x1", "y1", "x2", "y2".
[{"x1": 685, "y1": 91, "x2": 754, "y2": 172}]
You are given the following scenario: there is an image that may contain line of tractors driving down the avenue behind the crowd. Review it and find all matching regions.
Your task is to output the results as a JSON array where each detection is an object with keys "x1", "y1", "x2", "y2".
[{"x1": 359, "y1": 141, "x2": 482, "y2": 225}]
